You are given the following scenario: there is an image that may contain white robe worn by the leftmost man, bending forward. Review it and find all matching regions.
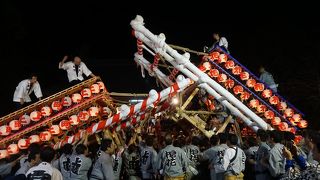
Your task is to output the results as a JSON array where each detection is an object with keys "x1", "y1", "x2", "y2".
[{"x1": 13, "y1": 79, "x2": 42, "y2": 102}]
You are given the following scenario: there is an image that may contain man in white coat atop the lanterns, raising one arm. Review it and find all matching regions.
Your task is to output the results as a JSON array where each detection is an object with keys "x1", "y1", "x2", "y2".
[{"x1": 59, "y1": 56, "x2": 95, "y2": 85}]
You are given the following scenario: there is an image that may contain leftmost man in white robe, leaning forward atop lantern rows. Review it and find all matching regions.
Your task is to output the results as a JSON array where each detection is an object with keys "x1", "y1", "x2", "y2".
[{"x1": 13, "y1": 75, "x2": 42, "y2": 108}]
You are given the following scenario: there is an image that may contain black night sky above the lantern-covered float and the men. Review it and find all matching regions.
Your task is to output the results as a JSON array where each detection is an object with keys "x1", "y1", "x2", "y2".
[{"x1": 0, "y1": 0, "x2": 320, "y2": 127}]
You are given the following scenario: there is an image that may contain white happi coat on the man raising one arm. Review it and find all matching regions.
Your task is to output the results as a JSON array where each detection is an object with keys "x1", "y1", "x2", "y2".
[{"x1": 59, "y1": 61, "x2": 92, "y2": 82}]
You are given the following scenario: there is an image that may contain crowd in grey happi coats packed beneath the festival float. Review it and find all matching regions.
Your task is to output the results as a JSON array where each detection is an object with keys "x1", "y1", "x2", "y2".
[{"x1": 0, "y1": 120, "x2": 320, "y2": 180}]
